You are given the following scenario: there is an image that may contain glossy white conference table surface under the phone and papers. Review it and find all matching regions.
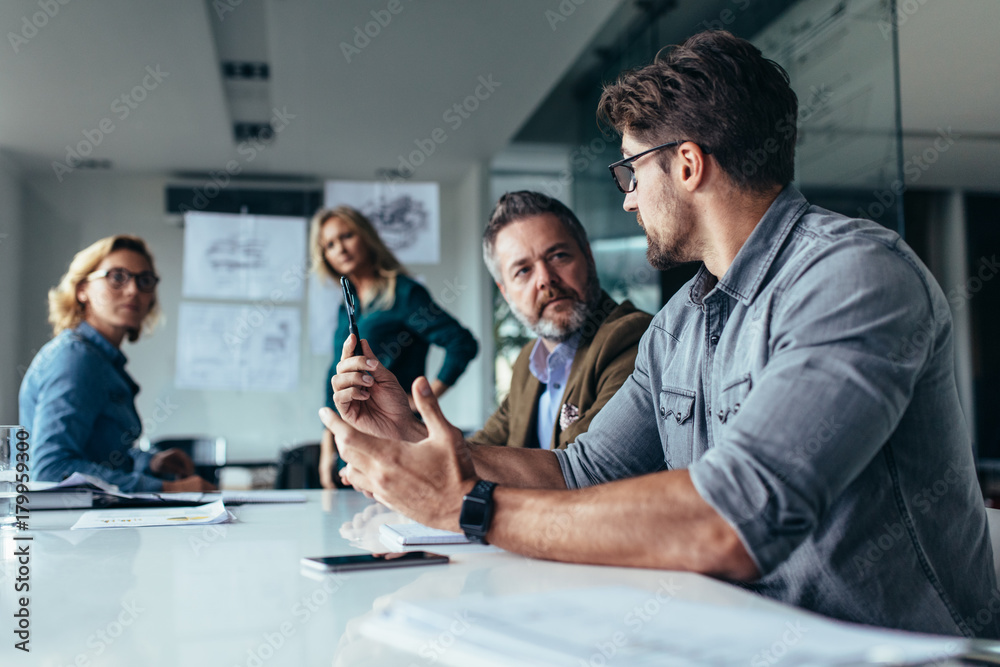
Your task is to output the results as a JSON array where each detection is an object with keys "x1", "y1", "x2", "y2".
[{"x1": 0, "y1": 491, "x2": 972, "y2": 667}]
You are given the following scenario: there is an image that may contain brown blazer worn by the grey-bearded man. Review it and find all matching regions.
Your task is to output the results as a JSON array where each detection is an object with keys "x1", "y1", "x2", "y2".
[{"x1": 469, "y1": 291, "x2": 653, "y2": 449}]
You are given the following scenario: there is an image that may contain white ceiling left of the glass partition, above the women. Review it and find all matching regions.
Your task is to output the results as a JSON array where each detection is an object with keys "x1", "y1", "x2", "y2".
[{"x1": 0, "y1": 0, "x2": 621, "y2": 180}]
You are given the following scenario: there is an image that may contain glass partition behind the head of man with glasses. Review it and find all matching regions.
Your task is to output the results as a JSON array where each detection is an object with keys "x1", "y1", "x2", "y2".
[{"x1": 493, "y1": 0, "x2": 903, "y2": 404}]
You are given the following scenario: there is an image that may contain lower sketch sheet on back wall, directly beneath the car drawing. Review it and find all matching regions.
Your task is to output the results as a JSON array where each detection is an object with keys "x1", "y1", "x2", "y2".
[{"x1": 174, "y1": 303, "x2": 302, "y2": 391}]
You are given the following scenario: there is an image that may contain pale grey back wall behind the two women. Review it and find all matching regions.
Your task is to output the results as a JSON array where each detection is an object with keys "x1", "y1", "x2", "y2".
[{"x1": 9, "y1": 166, "x2": 492, "y2": 460}]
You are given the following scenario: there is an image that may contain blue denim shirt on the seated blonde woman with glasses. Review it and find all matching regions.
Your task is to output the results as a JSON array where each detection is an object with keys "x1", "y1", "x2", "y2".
[{"x1": 19, "y1": 322, "x2": 163, "y2": 491}]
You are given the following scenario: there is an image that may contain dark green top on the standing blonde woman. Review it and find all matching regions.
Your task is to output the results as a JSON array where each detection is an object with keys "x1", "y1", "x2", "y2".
[{"x1": 326, "y1": 274, "x2": 479, "y2": 409}]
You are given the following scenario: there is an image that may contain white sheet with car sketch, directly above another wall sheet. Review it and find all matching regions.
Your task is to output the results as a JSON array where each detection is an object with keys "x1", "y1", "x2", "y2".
[{"x1": 183, "y1": 213, "x2": 308, "y2": 304}]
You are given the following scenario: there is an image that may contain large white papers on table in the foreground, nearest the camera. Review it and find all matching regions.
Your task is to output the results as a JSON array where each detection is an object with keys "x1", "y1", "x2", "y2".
[{"x1": 361, "y1": 586, "x2": 969, "y2": 667}]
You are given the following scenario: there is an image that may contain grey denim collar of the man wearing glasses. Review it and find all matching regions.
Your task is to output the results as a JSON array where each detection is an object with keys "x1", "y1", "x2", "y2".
[{"x1": 689, "y1": 185, "x2": 809, "y2": 305}]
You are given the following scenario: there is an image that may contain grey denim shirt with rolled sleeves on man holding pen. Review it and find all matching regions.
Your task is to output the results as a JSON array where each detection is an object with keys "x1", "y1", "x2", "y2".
[{"x1": 556, "y1": 187, "x2": 1000, "y2": 638}]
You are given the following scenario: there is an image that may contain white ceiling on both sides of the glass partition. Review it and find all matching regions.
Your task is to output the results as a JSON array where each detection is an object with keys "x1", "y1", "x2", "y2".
[{"x1": 0, "y1": 0, "x2": 1000, "y2": 191}]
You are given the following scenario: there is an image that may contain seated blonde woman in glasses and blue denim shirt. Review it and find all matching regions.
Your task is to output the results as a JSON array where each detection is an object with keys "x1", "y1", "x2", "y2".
[{"x1": 19, "y1": 235, "x2": 215, "y2": 492}]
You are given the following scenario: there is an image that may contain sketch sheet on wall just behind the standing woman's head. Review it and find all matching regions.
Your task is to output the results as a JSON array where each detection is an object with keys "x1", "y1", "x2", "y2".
[{"x1": 324, "y1": 181, "x2": 441, "y2": 264}]
